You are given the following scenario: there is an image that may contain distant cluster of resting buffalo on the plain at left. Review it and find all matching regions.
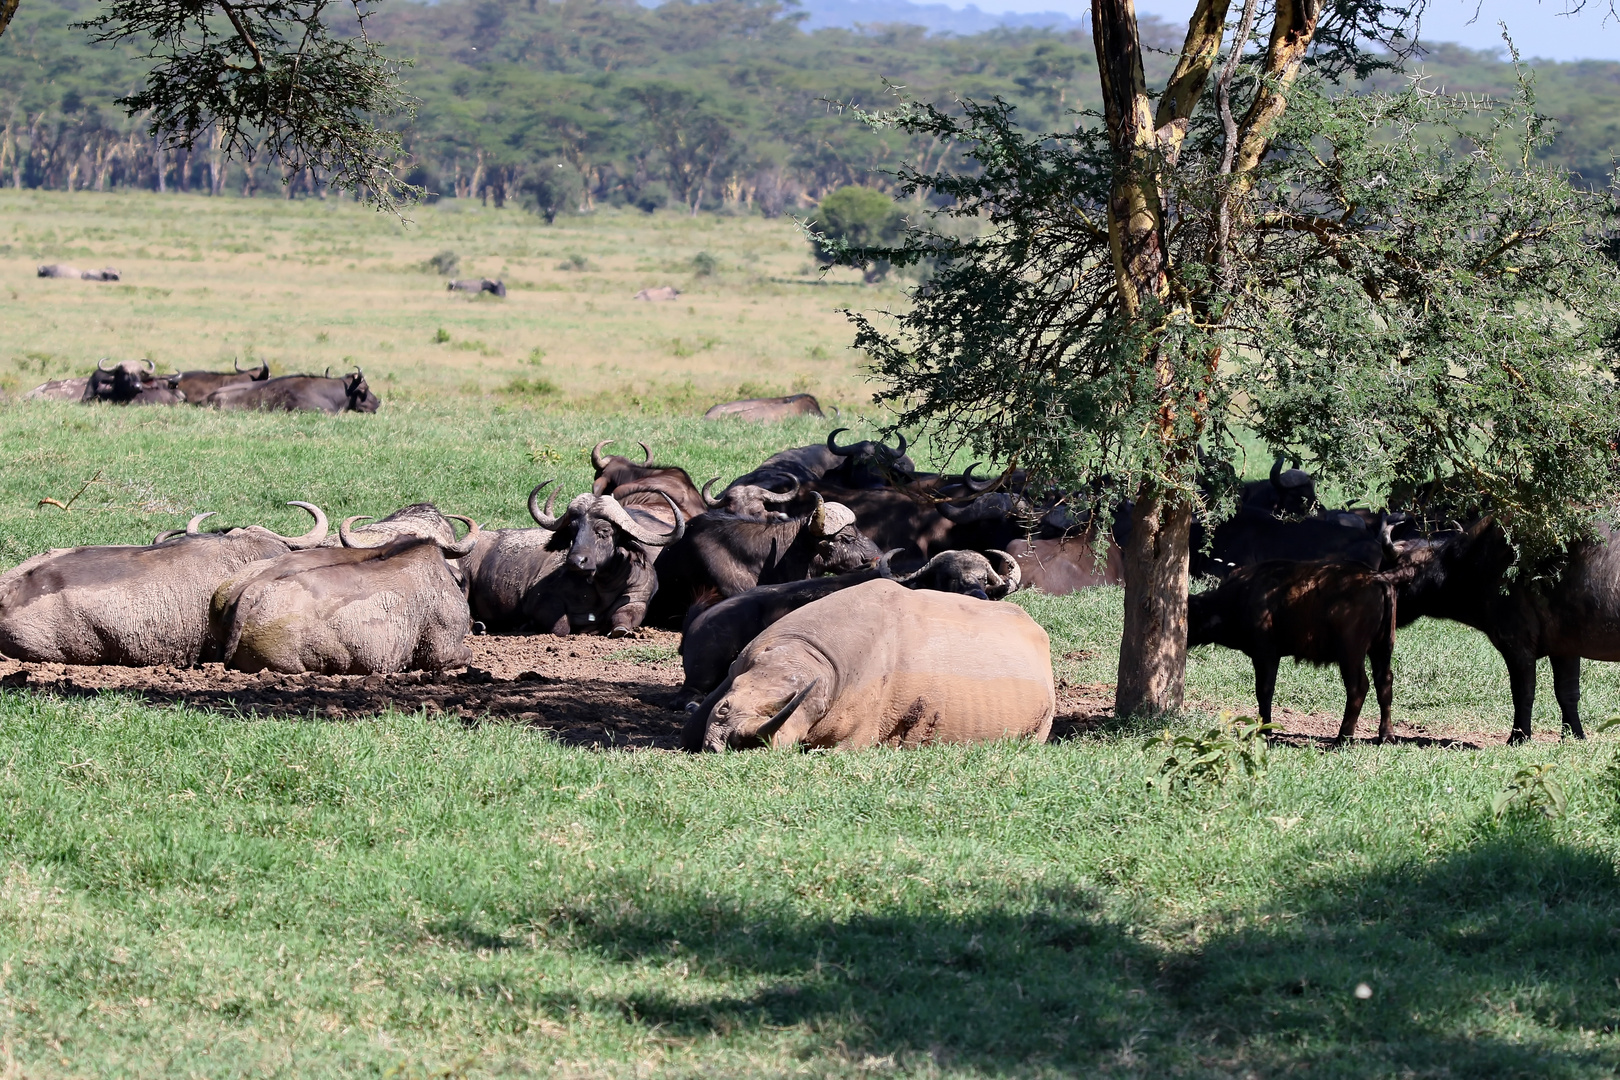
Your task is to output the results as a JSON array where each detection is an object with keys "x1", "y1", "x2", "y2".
[{"x1": 23, "y1": 359, "x2": 382, "y2": 413}]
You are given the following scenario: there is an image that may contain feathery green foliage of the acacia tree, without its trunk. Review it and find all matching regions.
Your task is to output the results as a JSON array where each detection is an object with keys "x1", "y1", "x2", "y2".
[{"x1": 842, "y1": 64, "x2": 1620, "y2": 563}]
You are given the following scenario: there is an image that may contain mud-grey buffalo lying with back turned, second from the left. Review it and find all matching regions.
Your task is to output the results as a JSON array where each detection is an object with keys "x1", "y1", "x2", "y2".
[{"x1": 209, "y1": 537, "x2": 476, "y2": 675}]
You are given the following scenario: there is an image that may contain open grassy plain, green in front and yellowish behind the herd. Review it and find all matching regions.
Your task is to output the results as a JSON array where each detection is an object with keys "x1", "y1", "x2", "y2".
[{"x1": 0, "y1": 191, "x2": 1620, "y2": 1078}]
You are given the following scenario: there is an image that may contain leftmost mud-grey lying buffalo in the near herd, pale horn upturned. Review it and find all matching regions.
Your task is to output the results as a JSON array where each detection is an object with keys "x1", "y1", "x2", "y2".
[{"x1": 0, "y1": 502, "x2": 327, "y2": 667}]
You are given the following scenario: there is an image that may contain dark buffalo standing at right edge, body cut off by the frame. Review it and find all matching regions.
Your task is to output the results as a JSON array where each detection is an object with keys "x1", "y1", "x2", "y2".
[{"x1": 1395, "y1": 518, "x2": 1620, "y2": 742}]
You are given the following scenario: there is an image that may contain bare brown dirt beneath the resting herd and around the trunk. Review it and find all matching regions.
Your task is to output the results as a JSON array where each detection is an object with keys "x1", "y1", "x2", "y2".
[{"x1": 0, "y1": 628, "x2": 1516, "y2": 750}]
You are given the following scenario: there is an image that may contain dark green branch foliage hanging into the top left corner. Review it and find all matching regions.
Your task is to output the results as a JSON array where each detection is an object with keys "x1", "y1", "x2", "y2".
[{"x1": 79, "y1": 0, "x2": 416, "y2": 210}]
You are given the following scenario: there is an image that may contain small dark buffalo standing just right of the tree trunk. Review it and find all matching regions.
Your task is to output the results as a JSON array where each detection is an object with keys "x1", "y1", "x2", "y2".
[{"x1": 1187, "y1": 550, "x2": 1396, "y2": 742}]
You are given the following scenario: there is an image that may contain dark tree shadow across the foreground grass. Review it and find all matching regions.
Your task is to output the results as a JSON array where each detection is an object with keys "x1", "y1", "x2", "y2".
[{"x1": 427, "y1": 831, "x2": 1620, "y2": 1080}]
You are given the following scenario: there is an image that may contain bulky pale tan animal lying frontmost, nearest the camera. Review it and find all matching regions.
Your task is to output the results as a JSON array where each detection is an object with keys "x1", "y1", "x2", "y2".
[{"x1": 682, "y1": 581, "x2": 1056, "y2": 750}]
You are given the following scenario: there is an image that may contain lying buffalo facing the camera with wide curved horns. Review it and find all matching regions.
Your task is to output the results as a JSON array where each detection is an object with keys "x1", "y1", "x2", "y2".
[{"x1": 462, "y1": 481, "x2": 687, "y2": 636}]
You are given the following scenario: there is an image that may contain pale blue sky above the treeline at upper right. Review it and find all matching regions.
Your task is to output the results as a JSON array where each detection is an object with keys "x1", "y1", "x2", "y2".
[{"x1": 923, "y1": 0, "x2": 1620, "y2": 60}]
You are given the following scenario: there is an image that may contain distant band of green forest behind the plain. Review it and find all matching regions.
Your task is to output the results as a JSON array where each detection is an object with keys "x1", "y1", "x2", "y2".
[{"x1": 0, "y1": 0, "x2": 1620, "y2": 208}]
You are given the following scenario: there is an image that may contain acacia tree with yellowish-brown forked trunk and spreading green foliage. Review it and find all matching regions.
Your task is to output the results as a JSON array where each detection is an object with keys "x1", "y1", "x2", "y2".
[{"x1": 844, "y1": 8, "x2": 1620, "y2": 716}]
